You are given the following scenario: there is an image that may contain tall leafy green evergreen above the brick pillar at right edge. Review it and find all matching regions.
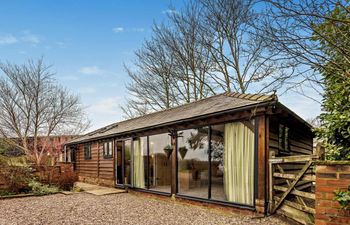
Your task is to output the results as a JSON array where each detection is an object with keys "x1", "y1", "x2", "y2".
[{"x1": 314, "y1": 3, "x2": 350, "y2": 160}]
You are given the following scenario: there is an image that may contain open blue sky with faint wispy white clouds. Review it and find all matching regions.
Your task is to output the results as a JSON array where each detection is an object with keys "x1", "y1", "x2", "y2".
[{"x1": 0, "y1": 0, "x2": 320, "y2": 129}]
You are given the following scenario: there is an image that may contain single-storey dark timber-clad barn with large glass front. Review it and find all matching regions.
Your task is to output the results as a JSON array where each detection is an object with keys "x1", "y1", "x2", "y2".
[{"x1": 65, "y1": 93, "x2": 313, "y2": 213}]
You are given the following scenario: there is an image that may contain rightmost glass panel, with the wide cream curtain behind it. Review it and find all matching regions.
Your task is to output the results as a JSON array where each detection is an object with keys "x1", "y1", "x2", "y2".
[{"x1": 211, "y1": 121, "x2": 255, "y2": 205}]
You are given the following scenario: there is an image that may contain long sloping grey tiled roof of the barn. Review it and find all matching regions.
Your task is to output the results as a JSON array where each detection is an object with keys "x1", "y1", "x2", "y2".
[{"x1": 66, "y1": 93, "x2": 277, "y2": 144}]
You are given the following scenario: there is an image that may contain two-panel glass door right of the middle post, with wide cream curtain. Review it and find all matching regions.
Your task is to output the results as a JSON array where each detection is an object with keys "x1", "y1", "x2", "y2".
[{"x1": 178, "y1": 121, "x2": 255, "y2": 205}]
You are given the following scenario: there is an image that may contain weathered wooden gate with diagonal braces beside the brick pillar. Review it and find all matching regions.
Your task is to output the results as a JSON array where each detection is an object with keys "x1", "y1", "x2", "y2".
[{"x1": 269, "y1": 152, "x2": 318, "y2": 224}]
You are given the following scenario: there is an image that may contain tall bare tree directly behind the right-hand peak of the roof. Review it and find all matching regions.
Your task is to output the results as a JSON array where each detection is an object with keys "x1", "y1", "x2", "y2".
[{"x1": 199, "y1": 0, "x2": 295, "y2": 93}]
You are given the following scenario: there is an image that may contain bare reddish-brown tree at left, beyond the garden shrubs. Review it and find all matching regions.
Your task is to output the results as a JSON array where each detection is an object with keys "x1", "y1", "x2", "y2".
[{"x1": 0, "y1": 59, "x2": 89, "y2": 164}]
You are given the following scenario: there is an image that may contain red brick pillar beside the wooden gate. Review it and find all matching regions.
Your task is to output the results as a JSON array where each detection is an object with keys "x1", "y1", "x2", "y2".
[{"x1": 315, "y1": 163, "x2": 350, "y2": 225}]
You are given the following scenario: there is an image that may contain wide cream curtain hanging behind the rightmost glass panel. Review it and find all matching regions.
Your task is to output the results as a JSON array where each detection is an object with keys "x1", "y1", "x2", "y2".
[{"x1": 224, "y1": 122, "x2": 254, "y2": 205}]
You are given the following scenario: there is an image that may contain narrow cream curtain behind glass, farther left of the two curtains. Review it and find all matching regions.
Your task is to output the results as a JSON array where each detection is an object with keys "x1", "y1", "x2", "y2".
[{"x1": 133, "y1": 139, "x2": 145, "y2": 188}]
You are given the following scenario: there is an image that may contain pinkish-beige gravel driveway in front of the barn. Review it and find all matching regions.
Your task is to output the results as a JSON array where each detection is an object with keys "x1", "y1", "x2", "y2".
[{"x1": 0, "y1": 193, "x2": 286, "y2": 225}]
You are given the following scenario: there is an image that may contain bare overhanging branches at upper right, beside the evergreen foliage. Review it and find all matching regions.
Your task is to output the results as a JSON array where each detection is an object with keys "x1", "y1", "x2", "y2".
[{"x1": 260, "y1": 0, "x2": 350, "y2": 101}]
